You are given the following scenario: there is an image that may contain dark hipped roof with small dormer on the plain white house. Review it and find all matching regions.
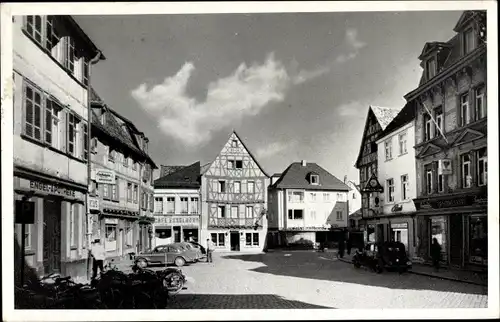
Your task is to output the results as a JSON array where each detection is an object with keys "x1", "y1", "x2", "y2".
[{"x1": 273, "y1": 162, "x2": 349, "y2": 191}]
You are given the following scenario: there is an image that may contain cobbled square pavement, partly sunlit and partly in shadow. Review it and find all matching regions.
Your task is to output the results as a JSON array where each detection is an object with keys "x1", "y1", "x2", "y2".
[{"x1": 109, "y1": 251, "x2": 488, "y2": 309}]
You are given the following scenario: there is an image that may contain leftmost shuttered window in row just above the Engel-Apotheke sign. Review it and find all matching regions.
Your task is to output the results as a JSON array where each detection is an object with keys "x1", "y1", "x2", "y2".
[{"x1": 24, "y1": 84, "x2": 42, "y2": 141}]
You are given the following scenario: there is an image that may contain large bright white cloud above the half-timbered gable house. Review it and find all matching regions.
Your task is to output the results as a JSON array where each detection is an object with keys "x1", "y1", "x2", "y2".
[{"x1": 131, "y1": 53, "x2": 292, "y2": 146}]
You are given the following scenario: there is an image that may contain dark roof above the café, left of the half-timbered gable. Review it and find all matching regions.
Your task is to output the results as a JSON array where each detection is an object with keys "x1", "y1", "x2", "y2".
[{"x1": 154, "y1": 161, "x2": 201, "y2": 189}]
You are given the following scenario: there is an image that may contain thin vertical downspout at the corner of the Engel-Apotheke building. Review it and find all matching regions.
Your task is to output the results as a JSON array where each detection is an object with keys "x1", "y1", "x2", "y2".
[{"x1": 85, "y1": 50, "x2": 103, "y2": 278}]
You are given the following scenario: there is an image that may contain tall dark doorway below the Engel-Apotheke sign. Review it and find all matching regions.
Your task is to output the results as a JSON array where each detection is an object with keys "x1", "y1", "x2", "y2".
[{"x1": 43, "y1": 199, "x2": 61, "y2": 274}]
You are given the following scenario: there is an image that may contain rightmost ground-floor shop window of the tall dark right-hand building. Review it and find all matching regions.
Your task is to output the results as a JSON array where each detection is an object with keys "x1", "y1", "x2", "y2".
[{"x1": 469, "y1": 215, "x2": 488, "y2": 264}]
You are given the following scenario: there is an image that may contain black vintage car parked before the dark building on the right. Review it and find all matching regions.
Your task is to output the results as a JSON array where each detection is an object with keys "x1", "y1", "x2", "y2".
[{"x1": 352, "y1": 241, "x2": 412, "y2": 273}]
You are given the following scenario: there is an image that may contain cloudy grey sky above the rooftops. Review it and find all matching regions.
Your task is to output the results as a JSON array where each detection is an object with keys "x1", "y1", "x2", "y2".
[{"x1": 75, "y1": 11, "x2": 461, "y2": 182}]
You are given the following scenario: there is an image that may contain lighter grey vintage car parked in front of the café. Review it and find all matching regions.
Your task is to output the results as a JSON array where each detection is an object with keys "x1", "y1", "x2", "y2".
[{"x1": 134, "y1": 244, "x2": 197, "y2": 268}]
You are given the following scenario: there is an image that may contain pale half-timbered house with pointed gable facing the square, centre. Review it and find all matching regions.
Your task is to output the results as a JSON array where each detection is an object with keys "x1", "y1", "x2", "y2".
[{"x1": 201, "y1": 131, "x2": 269, "y2": 252}]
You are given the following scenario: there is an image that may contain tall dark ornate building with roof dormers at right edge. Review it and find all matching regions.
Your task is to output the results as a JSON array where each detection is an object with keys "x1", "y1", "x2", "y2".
[{"x1": 405, "y1": 11, "x2": 488, "y2": 269}]
